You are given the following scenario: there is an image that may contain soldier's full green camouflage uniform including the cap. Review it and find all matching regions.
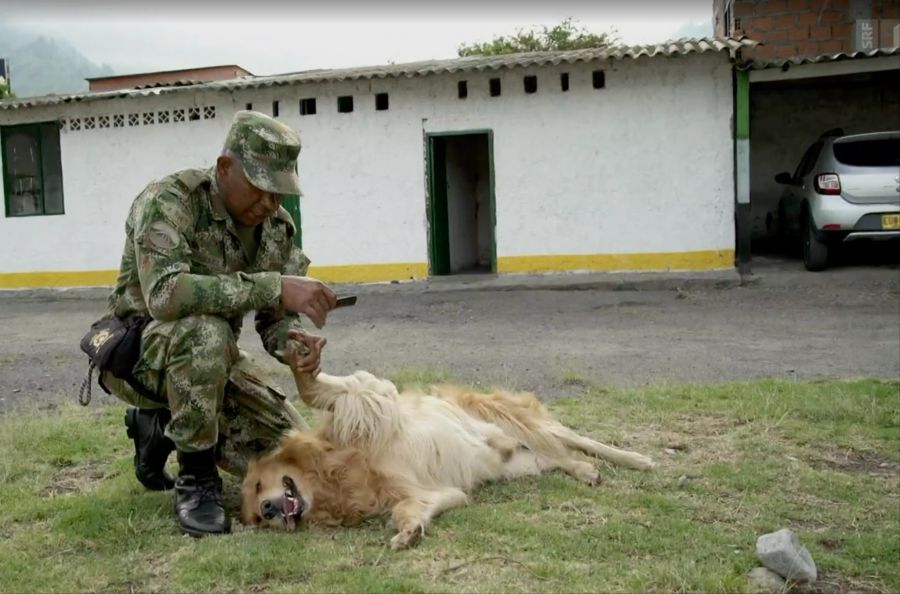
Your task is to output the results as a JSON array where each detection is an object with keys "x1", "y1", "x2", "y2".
[{"x1": 103, "y1": 112, "x2": 309, "y2": 474}]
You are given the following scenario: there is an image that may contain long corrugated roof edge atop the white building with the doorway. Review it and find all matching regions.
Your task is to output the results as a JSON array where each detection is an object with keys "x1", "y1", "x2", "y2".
[{"x1": 0, "y1": 37, "x2": 758, "y2": 109}]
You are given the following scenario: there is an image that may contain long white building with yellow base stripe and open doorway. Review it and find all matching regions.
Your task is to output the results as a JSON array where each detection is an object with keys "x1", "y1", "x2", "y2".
[{"x1": 0, "y1": 39, "x2": 752, "y2": 288}]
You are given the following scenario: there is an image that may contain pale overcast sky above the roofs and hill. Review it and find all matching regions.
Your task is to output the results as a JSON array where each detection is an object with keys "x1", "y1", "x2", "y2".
[{"x1": 0, "y1": 0, "x2": 712, "y2": 74}]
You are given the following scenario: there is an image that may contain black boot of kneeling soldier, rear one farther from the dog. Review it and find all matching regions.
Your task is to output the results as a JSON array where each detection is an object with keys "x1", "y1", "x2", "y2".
[{"x1": 125, "y1": 408, "x2": 175, "y2": 491}]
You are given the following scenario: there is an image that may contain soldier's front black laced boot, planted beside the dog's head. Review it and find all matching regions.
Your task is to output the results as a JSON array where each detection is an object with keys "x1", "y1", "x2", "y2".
[{"x1": 175, "y1": 448, "x2": 231, "y2": 536}]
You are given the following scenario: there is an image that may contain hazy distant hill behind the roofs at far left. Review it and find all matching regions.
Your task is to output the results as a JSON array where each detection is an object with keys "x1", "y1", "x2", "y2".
[{"x1": 0, "y1": 23, "x2": 115, "y2": 97}]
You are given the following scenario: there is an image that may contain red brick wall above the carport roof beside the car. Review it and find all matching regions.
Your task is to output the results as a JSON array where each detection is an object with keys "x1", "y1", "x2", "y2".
[{"x1": 714, "y1": 0, "x2": 900, "y2": 59}]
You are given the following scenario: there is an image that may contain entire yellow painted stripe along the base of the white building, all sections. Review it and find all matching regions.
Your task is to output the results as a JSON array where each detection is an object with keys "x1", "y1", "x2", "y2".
[{"x1": 0, "y1": 250, "x2": 734, "y2": 289}]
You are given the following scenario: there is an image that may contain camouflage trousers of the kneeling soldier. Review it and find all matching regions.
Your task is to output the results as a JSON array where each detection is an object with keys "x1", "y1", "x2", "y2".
[{"x1": 103, "y1": 315, "x2": 308, "y2": 476}]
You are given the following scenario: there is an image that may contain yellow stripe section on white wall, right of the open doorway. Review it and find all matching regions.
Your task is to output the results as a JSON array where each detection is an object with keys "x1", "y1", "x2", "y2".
[{"x1": 497, "y1": 250, "x2": 734, "y2": 272}]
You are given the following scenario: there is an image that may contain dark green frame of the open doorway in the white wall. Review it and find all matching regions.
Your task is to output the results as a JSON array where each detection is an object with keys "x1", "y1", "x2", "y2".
[{"x1": 425, "y1": 128, "x2": 497, "y2": 276}]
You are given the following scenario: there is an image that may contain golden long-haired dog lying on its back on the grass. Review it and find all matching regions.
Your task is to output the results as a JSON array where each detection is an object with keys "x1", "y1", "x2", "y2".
[{"x1": 241, "y1": 340, "x2": 654, "y2": 549}]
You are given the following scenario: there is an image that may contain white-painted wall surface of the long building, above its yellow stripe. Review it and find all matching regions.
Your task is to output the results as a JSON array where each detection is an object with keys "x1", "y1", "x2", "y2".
[{"x1": 0, "y1": 54, "x2": 734, "y2": 273}]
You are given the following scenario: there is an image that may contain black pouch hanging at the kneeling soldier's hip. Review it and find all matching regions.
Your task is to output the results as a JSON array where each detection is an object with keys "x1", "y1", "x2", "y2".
[{"x1": 78, "y1": 316, "x2": 159, "y2": 405}]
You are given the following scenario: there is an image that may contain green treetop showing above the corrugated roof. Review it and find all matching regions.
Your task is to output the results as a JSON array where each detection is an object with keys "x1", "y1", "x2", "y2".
[{"x1": 457, "y1": 17, "x2": 618, "y2": 57}]
